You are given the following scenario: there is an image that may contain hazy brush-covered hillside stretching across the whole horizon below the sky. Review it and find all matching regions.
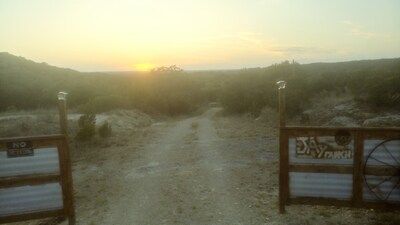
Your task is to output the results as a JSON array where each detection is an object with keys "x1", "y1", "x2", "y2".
[{"x1": 0, "y1": 53, "x2": 400, "y2": 116}]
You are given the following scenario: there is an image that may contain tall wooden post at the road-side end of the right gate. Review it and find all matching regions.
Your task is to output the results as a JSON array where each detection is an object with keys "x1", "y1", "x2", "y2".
[{"x1": 277, "y1": 81, "x2": 288, "y2": 213}]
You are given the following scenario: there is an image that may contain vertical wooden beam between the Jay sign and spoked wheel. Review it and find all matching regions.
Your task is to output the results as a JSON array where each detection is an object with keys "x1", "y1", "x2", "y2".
[{"x1": 353, "y1": 131, "x2": 364, "y2": 207}]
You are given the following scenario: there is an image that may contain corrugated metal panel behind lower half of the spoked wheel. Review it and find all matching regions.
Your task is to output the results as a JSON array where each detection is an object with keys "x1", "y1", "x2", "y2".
[{"x1": 363, "y1": 175, "x2": 400, "y2": 202}]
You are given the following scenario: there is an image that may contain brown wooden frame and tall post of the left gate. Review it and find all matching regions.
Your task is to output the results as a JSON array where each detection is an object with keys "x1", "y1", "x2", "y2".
[{"x1": 0, "y1": 92, "x2": 76, "y2": 225}]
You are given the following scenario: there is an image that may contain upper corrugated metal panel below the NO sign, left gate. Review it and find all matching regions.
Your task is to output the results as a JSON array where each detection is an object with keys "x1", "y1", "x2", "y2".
[{"x1": 0, "y1": 148, "x2": 60, "y2": 177}]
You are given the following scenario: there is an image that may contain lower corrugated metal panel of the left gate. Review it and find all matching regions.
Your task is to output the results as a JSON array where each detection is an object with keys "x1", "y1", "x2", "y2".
[{"x1": 0, "y1": 183, "x2": 63, "y2": 216}]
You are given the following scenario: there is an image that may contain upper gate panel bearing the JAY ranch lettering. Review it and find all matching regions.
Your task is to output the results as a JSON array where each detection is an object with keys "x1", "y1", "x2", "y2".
[{"x1": 289, "y1": 136, "x2": 354, "y2": 165}]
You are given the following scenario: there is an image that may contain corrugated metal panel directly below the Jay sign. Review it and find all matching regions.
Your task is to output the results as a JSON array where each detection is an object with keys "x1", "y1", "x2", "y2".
[{"x1": 289, "y1": 172, "x2": 353, "y2": 199}]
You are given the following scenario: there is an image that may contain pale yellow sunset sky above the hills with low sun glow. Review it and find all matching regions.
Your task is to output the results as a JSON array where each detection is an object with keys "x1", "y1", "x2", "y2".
[{"x1": 0, "y1": 0, "x2": 400, "y2": 71}]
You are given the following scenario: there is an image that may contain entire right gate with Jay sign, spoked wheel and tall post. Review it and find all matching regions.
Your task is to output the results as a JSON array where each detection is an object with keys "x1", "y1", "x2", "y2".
[{"x1": 279, "y1": 83, "x2": 400, "y2": 213}]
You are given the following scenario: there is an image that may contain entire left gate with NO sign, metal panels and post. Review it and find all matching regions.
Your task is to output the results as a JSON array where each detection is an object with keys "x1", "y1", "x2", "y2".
[{"x1": 0, "y1": 92, "x2": 75, "y2": 225}]
